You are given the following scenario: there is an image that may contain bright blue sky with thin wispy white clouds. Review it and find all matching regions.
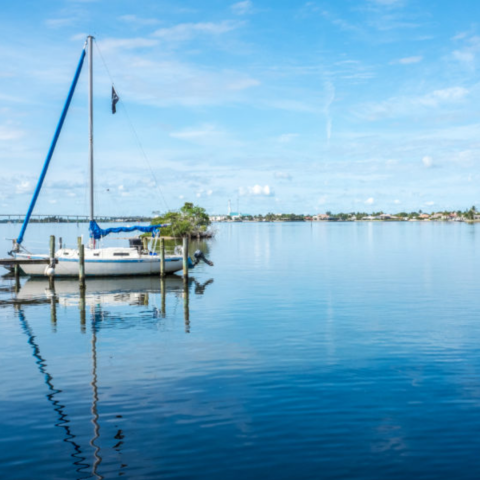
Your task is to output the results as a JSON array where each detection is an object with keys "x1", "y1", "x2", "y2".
[{"x1": 0, "y1": 0, "x2": 480, "y2": 215}]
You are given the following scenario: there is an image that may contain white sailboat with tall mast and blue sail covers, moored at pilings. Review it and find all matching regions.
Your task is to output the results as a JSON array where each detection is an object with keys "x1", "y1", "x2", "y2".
[{"x1": 10, "y1": 35, "x2": 194, "y2": 277}]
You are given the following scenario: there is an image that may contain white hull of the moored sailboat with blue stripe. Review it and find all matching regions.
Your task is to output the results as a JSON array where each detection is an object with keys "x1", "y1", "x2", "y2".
[{"x1": 16, "y1": 248, "x2": 183, "y2": 277}]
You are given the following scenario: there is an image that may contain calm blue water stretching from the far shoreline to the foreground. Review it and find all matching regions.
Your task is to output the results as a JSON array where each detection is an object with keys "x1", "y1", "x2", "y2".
[{"x1": 0, "y1": 222, "x2": 480, "y2": 480}]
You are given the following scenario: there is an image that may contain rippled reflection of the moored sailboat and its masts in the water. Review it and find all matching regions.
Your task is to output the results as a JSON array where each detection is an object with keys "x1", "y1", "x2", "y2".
[{"x1": 11, "y1": 275, "x2": 213, "y2": 479}]
